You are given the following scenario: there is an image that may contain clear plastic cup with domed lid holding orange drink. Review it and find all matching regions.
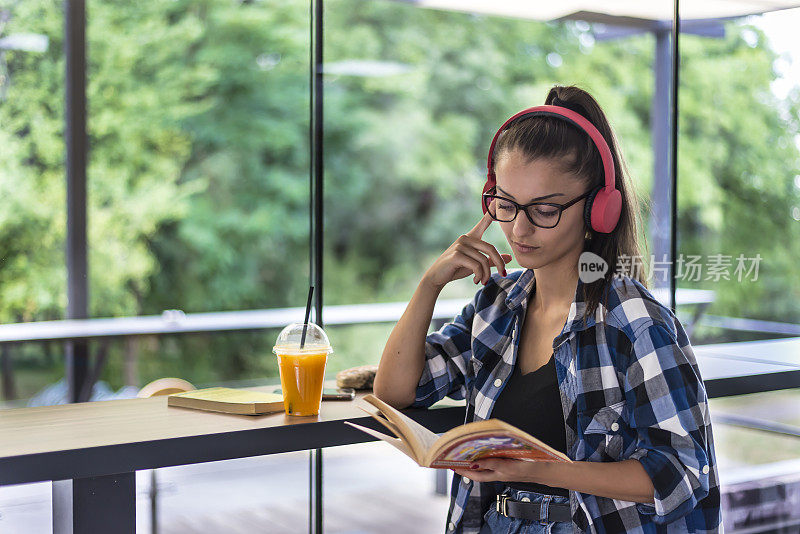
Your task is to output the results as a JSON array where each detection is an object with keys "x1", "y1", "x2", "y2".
[{"x1": 272, "y1": 323, "x2": 333, "y2": 415}]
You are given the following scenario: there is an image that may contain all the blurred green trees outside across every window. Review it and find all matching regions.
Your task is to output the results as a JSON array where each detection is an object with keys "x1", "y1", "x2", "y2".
[{"x1": 0, "y1": 0, "x2": 800, "y2": 400}]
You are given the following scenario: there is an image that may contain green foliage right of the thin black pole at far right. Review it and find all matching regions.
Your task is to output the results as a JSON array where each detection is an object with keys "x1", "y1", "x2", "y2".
[{"x1": 678, "y1": 28, "x2": 800, "y2": 322}]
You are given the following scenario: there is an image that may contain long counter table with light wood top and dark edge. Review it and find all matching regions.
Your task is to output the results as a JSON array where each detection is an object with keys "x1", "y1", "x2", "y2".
[{"x1": 0, "y1": 340, "x2": 800, "y2": 534}]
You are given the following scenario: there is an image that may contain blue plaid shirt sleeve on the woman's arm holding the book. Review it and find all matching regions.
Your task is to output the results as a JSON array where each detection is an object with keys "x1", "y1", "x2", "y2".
[{"x1": 624, "y1": 323, "x2": 714, "y2": 524}]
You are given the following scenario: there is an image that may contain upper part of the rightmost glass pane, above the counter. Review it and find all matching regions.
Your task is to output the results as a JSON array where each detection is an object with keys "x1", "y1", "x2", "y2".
[{"x1": 676, "y1": 9, "x2": 800, "y2": 344}]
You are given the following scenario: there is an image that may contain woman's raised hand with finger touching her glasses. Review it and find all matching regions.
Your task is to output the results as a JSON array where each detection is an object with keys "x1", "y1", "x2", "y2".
[{"x1": 423, "y1": 212, "x2": 511, "y2": 289}]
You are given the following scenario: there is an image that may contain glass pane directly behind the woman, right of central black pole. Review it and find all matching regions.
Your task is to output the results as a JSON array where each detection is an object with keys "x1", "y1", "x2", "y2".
[{"x1": 324, "y1": 0, "x2": 668, "y2": 532}]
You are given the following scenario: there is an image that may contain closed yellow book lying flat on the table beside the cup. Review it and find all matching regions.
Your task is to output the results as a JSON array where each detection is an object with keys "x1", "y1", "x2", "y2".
[{"x1": 167, "y1": 388, "x2": 283, "y2": 415}]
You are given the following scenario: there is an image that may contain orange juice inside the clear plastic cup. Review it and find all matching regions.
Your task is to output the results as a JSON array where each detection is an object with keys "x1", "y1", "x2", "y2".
[{"x1": 276, "y1": 349, "x2": 328, "y2": 415}]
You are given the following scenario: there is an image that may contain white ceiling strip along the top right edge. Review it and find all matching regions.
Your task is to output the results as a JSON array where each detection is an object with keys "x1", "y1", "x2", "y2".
[{"x1": 410, "y1": 0, "x2": 800, "y2": 20}]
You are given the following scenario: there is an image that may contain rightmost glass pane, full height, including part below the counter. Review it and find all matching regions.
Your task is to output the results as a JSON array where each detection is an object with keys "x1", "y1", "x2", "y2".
[{"x1": 676, "y1": 4, "x2": 800, "y2": 531}]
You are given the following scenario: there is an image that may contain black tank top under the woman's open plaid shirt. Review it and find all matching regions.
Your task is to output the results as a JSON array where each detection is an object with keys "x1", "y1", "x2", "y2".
[{"x1": 491, "y1": 355, "x2": 569, "y2": 497}]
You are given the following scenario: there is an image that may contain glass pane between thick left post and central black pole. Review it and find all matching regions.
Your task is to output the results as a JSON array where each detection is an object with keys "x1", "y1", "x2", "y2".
[{"x1": 81, "y1": 0, "x2": 310, "y2": 394}]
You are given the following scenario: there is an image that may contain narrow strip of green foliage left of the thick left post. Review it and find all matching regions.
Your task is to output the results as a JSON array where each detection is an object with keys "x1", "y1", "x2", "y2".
[{"x1": 0, "y1": 2, "x2": 66, "y2": 322}]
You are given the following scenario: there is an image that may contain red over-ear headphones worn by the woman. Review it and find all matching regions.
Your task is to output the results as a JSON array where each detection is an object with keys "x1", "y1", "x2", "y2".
[{"x1": 481, "y1": 106, "x2": 622, "y2": 234}]
